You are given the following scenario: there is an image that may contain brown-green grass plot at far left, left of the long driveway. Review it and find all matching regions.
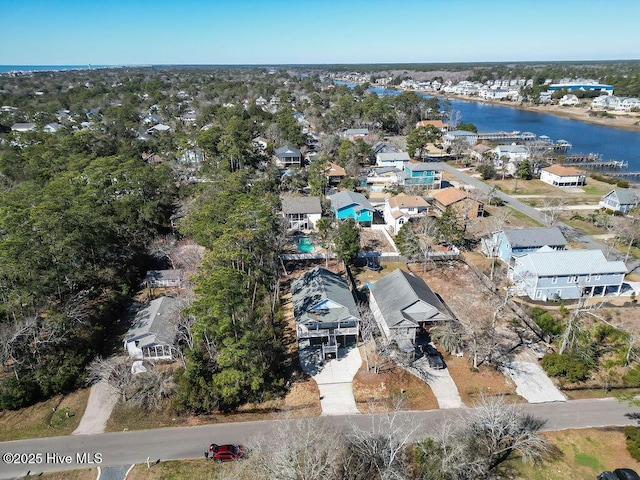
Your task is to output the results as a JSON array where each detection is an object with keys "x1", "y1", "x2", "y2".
[{"x1": 0, "y1": 388, "x2": 89, "y2": 442}]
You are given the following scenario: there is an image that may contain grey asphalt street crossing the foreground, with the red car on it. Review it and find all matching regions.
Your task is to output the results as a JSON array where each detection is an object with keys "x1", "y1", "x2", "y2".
[{"x1": 0, "y1": 399, "x2": 637, "y2": 479}]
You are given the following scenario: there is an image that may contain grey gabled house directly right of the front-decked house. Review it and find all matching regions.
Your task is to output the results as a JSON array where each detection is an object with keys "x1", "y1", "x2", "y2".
[{"x1": 369, "y1": 269, "x2": 451, "y2": 352}]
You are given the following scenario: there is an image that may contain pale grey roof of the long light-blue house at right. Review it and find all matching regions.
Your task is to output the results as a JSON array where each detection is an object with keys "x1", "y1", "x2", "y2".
[{"x1": 517, "y1": 250, "x2": 627, "y2": 277}]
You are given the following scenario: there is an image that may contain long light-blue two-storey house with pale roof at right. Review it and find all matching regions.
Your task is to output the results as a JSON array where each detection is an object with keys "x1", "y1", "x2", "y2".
[{"x1": 508, "y1": 247, "x2": 627, "y2": 301}]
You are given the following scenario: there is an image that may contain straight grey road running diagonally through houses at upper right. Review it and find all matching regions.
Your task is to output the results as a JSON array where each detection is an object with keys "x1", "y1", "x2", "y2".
[{"x1": 442, "y1": 163, "x2": 640, "y2": 272}]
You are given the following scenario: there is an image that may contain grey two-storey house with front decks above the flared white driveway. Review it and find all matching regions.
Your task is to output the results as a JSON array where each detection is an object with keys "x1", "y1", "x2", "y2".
[{"x1": 291, "y1": 267, "x2": 360, "y2": 358}]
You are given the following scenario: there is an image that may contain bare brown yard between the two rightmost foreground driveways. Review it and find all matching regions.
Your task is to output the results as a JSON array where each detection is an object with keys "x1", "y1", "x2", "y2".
[{"x1": 444, "y1": 355, "x2": 523, "y2": 406}]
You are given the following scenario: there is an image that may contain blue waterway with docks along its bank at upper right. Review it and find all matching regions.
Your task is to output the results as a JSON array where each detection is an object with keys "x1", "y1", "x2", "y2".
[{"x1": 335, "y1": 82, "x2": 640, "y2": 171}]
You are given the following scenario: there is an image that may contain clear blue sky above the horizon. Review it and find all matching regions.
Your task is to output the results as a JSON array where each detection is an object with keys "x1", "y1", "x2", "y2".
[{"x1": 0, "y1": 0, "x2": 640, "y2": 65}]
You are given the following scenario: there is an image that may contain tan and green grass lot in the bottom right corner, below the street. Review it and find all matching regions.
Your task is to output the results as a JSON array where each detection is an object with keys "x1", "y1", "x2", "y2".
[{"x1": 506, "y1": 428, "x2": 640, "y2": 480}]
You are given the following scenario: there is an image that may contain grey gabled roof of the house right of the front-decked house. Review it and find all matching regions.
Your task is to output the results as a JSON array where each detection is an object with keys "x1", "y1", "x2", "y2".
[{"x1": 369, "y1": 269, "x2": 451, "y2": 327}]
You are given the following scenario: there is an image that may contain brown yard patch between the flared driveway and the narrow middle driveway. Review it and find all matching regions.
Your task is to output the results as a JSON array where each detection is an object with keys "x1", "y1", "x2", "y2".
[{"x1": 353, "y1": 348, "x2": 438, "y2": 413}]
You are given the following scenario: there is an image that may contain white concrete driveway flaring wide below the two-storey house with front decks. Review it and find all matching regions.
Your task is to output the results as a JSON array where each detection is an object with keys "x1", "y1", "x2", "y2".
[{"x1": 298, "y1": 346, "x2": 362, "y2": 415}]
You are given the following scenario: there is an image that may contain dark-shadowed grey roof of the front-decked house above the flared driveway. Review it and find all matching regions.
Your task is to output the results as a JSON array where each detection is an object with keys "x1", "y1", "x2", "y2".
[{"x1": 291, "y1": 267, "x2": 358, "y2": 323}]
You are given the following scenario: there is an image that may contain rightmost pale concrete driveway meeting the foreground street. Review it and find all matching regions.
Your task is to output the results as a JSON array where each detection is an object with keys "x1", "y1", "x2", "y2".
[{"x1": 503, "y1": 361, "x2": 567, "y2": 403}]
